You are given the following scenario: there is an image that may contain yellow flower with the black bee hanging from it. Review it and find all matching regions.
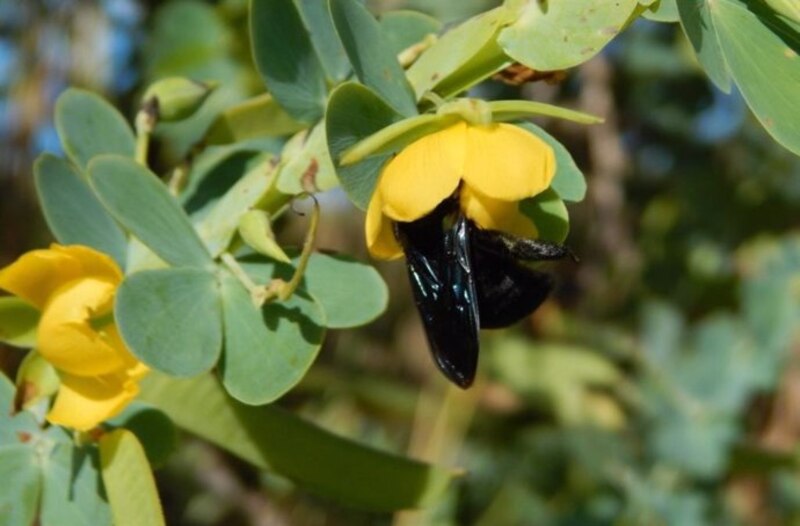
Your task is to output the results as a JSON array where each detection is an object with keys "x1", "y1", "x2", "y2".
[{"x1": 366, "y1": 121, "x2": 556, "y2": 259}]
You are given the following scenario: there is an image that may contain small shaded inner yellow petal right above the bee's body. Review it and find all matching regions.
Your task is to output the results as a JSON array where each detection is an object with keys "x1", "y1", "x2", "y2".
[{"x1": 460, "y1": 185, "x2": 539, "y2": 239}]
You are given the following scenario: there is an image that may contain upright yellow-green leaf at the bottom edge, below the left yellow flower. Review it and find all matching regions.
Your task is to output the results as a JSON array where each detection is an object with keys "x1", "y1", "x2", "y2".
[{"x1": 100, "y1": 429, "x2": 166, "y2": 526}]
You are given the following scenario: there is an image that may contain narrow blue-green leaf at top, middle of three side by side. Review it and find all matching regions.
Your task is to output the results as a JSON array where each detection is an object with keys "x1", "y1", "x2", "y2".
[{"x1": 295, "y1": 0, "x2": 350, "y2": 84}]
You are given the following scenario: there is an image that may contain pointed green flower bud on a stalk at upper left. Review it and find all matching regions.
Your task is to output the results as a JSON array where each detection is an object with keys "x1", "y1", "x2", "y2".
[{"x1": 142, "y1": 77, "x2": 217, "y2": 122}]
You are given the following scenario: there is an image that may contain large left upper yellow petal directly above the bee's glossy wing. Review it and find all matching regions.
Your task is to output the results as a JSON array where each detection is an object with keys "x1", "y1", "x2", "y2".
[{"x1": 377, "y1": 122, "x2": 467, "y2": 221}]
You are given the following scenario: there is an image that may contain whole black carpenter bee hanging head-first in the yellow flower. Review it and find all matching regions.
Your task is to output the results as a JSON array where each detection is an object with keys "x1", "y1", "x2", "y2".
[{"x1": 395, "y1": 196, "x2": 574, "y2": 388}]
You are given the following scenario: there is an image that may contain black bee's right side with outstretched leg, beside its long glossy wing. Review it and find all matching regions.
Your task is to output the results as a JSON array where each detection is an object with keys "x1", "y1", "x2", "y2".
[{"x1": 470, "y1": 224, "x2": 570, "y2": 329}]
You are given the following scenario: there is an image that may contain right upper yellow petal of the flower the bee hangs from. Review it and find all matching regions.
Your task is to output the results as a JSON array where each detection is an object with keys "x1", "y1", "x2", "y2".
[{"x1": 464, "y1": 124, "x2": 556, "y2": 201}]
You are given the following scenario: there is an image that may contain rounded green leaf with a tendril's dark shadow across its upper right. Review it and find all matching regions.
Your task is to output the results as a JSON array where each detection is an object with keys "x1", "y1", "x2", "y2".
[{"x1": 219, "y1": 276, "x2": 325, "y2": 405}]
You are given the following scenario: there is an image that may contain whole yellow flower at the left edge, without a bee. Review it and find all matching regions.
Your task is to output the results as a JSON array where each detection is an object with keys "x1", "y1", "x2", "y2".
[{"x1": 0, "y1": 244, "x2": 148, "y2": 431}]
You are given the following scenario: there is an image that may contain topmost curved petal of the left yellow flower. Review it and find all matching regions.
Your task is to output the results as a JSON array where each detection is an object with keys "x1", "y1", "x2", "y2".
[{"x1": 0, "y1": 244, "x2": 122, "y2": 309}]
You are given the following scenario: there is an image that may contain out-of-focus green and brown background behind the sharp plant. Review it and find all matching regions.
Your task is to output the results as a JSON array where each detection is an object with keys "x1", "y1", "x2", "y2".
[{"x1": 0, "y1": 0, "x2": 800, "y2": 526}]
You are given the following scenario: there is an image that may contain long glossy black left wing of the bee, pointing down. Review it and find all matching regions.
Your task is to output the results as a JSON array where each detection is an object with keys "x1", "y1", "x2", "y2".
[{"x1": 396, "y1": 202, "x2": 479, "y2": 388}]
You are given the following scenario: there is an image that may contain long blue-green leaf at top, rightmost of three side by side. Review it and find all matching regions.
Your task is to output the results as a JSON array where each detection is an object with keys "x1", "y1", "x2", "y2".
[{"x1": 328, "y1": 0, "x2": 417, "y2": 117}]
